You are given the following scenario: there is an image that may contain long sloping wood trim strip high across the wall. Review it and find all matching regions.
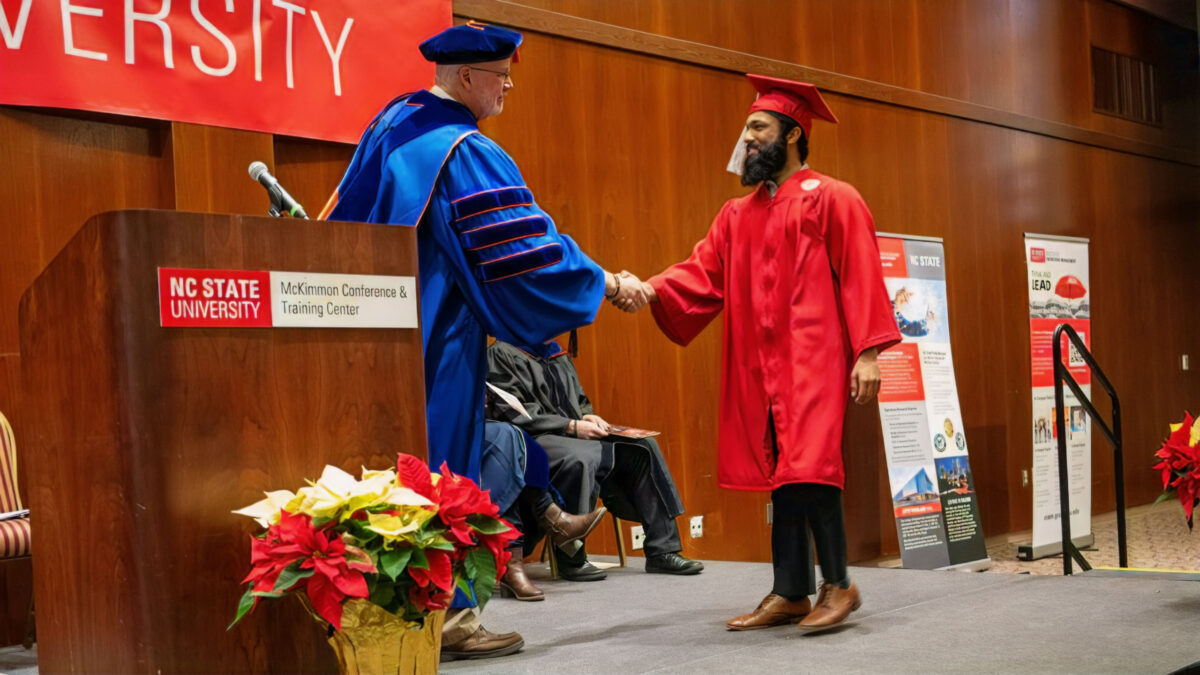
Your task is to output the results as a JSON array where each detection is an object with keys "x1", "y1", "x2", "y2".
[{"x1": 454, "y1": 0, "x2": 1200, "y2": 167}]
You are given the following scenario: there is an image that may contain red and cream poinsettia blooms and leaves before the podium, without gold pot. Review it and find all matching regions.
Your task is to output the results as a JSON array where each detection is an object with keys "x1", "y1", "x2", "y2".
[{"x1": 230, "y1": 454, "x2": 517, "y2": 631}]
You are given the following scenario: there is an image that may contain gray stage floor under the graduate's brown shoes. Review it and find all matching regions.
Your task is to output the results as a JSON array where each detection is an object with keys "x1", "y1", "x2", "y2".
[{"x1": 442, "y1": 558, "x2": 1200, "y2": 674}]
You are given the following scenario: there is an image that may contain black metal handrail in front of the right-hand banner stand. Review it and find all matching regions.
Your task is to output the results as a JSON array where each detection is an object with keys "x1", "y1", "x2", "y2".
[{"x1": 1054, "y1": 323, "x2": 1129, "y2": 575}]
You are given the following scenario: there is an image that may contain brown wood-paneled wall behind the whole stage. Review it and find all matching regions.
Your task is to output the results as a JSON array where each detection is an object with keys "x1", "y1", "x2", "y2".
[{"x1": 0, "y1": 0, "x2": 1200, "y2": 644}]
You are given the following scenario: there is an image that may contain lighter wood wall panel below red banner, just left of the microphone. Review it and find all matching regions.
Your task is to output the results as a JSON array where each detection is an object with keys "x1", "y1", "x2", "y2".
[{"x1": 170, "y1": 121, "x2": 275, "y2": 215}]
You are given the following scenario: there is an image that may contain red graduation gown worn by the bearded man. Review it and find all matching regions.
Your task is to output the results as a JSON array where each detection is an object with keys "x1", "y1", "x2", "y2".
[{"x1": 649, "y1": 169, "x2": 900, "y2": 490}]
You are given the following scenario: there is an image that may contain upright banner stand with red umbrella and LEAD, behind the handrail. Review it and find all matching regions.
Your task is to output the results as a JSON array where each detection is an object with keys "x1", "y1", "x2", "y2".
[{"x1": 1018, "y1": 233, "x2": 1093, "y2": 560}]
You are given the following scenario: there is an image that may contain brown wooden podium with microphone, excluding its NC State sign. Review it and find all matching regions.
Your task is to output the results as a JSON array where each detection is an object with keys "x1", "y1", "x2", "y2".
[{"x1": 20, "y1": 211, "x2": 426, "y2": 675}]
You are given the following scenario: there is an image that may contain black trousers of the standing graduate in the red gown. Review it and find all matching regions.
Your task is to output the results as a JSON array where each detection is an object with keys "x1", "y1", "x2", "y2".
[{"x1": 770, "y1": 483, "x2": 850, "y2": 601}]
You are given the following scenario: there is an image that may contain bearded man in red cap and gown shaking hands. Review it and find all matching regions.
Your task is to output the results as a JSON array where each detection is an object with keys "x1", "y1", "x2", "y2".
[{"x1": 643, "y1": 74, "x2": 900, "y2": 631}]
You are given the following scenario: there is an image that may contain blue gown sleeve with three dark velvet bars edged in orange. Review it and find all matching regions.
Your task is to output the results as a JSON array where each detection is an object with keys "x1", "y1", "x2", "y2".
[{"x1": 422, "y1": 133, "x2": 605, "y2": 345}]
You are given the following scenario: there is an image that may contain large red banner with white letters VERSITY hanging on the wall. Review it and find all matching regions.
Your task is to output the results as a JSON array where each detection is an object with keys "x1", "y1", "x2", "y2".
[{"x1": 0, "y1": 0, "x2": 451, "y2": 143}]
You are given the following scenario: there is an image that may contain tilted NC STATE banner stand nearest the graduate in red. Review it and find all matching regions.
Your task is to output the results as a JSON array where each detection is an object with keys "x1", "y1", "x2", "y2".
[{"x1": 878, "y1": 234, "x2": 991, "y2": 569}]
